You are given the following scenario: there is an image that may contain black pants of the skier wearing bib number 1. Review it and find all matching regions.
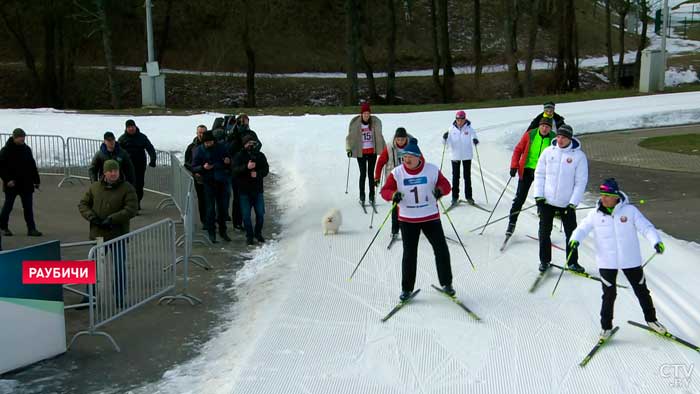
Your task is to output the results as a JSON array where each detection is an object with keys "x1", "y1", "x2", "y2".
[{"x1": 401, "y1": 219, "x2": 452, "y2": 292}]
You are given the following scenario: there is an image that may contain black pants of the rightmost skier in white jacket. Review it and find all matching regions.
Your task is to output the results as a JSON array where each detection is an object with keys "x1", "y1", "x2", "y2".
[{"x1": 599, "y1": 267, "x2": 656, "y2": 330}]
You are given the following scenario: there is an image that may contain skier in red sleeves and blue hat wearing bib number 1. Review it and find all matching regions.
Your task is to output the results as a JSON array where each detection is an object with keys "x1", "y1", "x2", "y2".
[{"x1": 381, "y1": 140, "x2": 455, "y2": 301}]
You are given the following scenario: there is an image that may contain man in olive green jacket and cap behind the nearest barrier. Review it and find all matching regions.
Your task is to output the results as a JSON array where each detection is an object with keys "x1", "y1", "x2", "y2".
[{"x1": 78, "y1": 160, "x2": 138, "y2": 308}]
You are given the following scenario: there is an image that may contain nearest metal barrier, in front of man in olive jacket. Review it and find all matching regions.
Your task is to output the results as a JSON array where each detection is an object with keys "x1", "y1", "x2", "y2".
[{"x1": 69, "y1": 219, "x2": 177, "y2": 351}]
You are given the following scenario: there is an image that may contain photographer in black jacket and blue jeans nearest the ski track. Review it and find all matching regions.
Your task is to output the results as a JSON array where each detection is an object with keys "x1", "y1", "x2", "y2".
[{"x1": 233, "y1": 134, "x2": 270, "y2": 245}]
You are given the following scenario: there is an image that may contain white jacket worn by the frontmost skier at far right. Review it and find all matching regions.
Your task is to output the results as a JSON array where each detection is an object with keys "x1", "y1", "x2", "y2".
[{"x1": 571, "y1": 193, "x2": 661, "y2": 269}]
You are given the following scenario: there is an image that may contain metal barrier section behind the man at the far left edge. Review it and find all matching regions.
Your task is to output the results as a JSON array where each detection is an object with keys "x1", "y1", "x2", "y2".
[{"x1": 0, "y1": 133, "x2": 68, "y2": 179}]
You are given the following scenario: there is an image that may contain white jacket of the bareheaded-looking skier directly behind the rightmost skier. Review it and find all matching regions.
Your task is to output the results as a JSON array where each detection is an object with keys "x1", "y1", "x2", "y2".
[{"x1": 535, "y1": 138, "x2": 588, "y2": 208}]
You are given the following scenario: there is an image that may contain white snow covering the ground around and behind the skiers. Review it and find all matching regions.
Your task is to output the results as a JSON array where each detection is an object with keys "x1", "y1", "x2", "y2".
[{"x1": 0, "y1": 93, "x2": 700, "y2": 394}]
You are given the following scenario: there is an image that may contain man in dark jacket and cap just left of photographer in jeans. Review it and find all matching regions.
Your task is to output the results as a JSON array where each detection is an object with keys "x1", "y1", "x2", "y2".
[{"x1": 192, "y1": 131, "x2": 231, "y2": 243}]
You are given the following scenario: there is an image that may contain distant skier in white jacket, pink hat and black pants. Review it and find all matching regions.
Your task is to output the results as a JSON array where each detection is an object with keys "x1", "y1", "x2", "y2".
[{"x1": 442, "y1": 111, "x2": 479, "y2": 205}]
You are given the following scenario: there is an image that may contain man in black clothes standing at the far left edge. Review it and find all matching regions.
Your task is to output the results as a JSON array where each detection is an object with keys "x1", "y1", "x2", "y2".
[{"x1": 0, "y1": 129, "x2": 42, "y2": 237}]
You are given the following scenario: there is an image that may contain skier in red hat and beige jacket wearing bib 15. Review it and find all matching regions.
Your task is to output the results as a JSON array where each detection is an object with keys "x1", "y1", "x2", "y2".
[{"x1": 345, "y1": 102, "x2": 385, "y2": 206}]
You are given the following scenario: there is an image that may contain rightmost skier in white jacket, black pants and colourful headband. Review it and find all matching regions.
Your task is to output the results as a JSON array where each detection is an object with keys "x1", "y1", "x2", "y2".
[{"x1": 570, "y1": 178, "x2": 666, "y2": 339}]
